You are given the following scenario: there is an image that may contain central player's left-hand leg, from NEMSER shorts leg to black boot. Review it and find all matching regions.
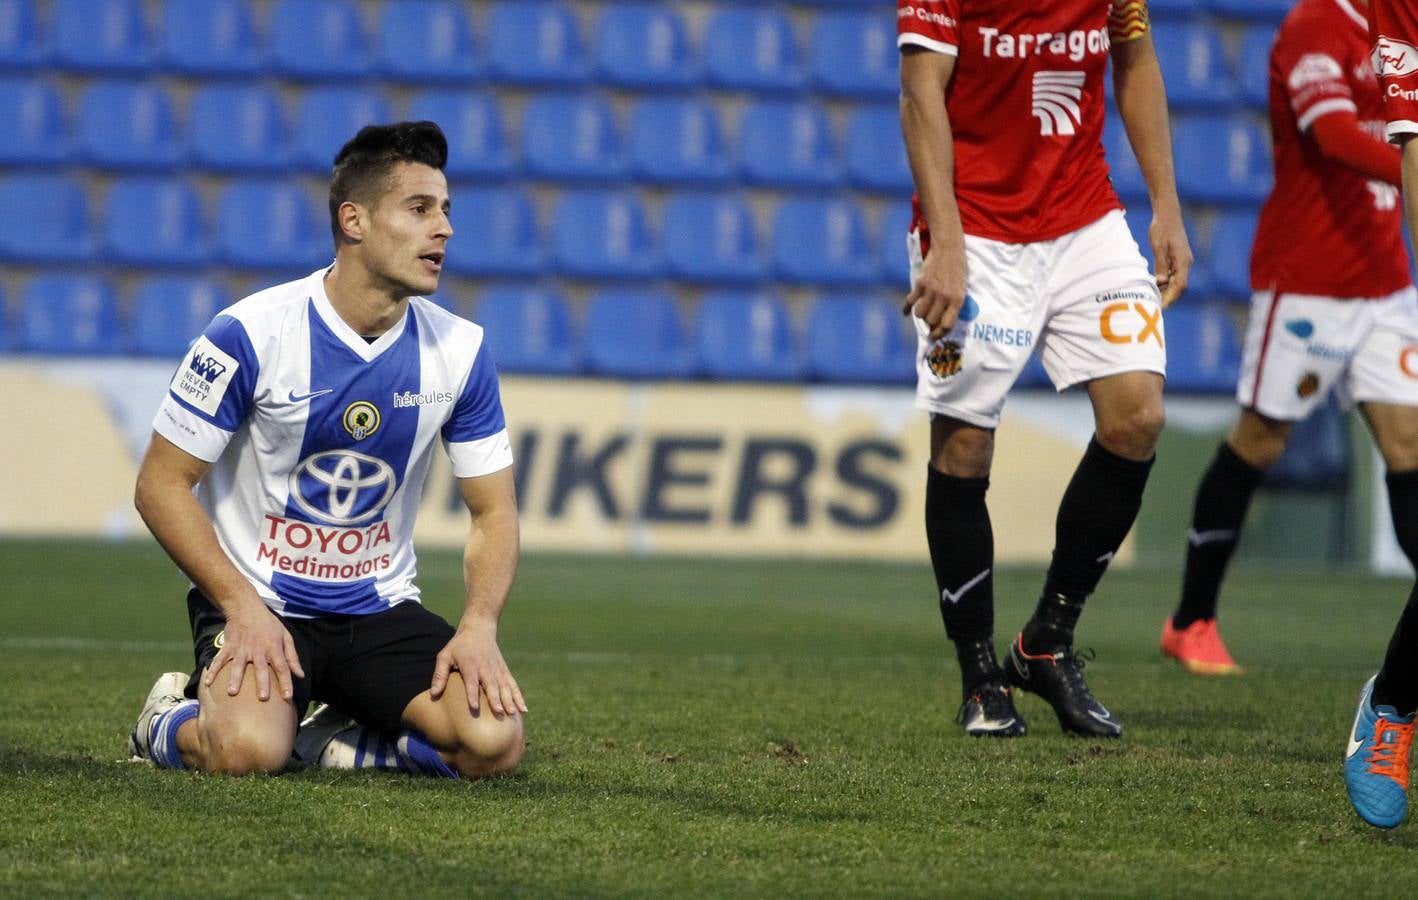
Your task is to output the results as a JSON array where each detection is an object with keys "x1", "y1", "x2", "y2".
[{"x1": 908, "y1": 226, "x2": 1042, "y2": 737}]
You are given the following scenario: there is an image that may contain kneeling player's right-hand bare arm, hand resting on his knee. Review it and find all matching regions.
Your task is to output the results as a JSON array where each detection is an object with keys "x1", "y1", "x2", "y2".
[{"x1": 430, "y1": 466, "x2": 527, "y2": 719}]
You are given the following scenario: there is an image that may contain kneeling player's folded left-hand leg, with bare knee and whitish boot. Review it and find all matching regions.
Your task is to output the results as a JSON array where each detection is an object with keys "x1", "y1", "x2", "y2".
[{"x1": 129, "y1": 590, "x2": 312, "y2": 775}]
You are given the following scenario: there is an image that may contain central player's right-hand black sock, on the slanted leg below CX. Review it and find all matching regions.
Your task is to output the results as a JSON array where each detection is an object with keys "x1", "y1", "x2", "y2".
[{"x1": 1024, "y1": 437, "x2": 1153, "y2": 649}]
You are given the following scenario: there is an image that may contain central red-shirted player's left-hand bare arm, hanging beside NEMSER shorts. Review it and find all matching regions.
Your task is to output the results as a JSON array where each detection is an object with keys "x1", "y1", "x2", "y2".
[{"x1": 900, "y1": 45, "x2": 966, "y2": 340}]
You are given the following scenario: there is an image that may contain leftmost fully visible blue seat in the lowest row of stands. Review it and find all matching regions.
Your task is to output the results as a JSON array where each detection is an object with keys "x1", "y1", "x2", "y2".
[{"x1": 18, "y1": 272, "x2": 122, "y2": 356}]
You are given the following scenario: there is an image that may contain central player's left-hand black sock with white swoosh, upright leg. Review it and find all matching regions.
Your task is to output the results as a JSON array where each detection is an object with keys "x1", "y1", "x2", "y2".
[{"x1": 926, "y1": 466, "x2": 998, "y2": 682}]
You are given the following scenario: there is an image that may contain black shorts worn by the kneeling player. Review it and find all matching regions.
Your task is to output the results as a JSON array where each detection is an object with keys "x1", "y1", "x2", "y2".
[{"x1": 187, "y1": 588, "x2": 454, "y2": 731}]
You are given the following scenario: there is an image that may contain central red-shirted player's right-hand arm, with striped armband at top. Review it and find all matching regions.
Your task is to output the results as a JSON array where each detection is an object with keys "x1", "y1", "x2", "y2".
[{"x1": 1112, "y1": 20, "x2": 1191, "y2": 306}]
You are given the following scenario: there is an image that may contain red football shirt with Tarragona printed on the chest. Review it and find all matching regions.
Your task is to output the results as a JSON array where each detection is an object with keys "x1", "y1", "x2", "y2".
[{"x1": 896, "y1": 0, "x2": 1146, "y2": 244}]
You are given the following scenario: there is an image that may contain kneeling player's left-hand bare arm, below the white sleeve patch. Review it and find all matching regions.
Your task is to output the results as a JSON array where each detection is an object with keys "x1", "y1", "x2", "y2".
[{"x1": 133, "y1": 434, "x2": 305, "y2": 700}]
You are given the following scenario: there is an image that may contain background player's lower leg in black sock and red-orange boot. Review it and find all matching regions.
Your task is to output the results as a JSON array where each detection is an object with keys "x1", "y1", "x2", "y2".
[{"x1": 1161, "y1": 408, "x2": 1293, "y2": 675}]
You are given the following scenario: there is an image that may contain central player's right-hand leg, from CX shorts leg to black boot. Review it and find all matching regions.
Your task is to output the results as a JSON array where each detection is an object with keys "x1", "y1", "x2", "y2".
[{"x1": 1005, "y1": 213, "x2": 1167, "y2": 737}]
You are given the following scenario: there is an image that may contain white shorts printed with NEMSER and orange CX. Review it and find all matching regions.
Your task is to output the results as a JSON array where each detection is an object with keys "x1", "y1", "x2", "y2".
[{"x1": 906, "y1": 210, "x2": 1167, "y2": 428}]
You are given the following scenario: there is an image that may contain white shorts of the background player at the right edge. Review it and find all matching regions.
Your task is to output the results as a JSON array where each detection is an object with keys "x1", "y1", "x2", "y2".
[{"x1": 1236, "y1": 288, "x2": 1418, "y2": 422}]
